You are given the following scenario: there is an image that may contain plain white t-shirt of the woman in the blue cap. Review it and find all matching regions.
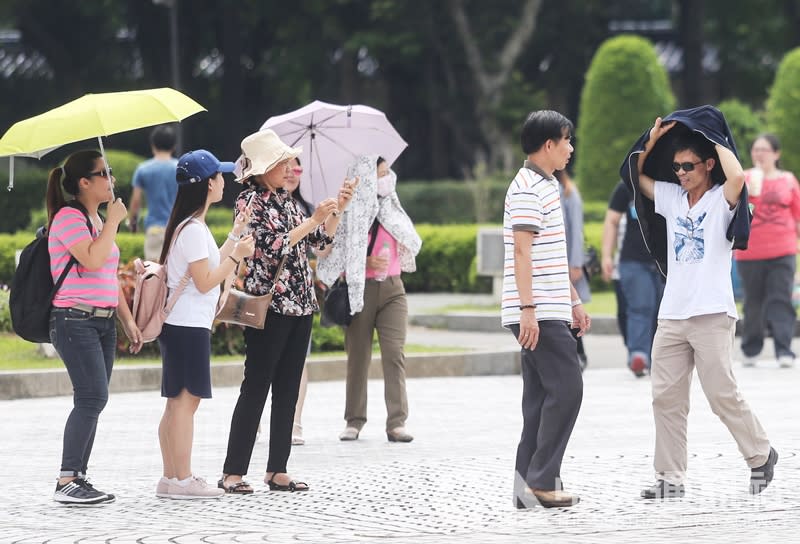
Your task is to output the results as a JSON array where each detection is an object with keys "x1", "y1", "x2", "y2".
[{"x1": 166, "y1": 219, "x2": 219, "y2": 329}]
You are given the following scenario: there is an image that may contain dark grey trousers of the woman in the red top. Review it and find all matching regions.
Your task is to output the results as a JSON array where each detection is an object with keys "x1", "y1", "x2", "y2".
[{"x1": 736, "y1": 255, "x2": 796, "y2": 358}]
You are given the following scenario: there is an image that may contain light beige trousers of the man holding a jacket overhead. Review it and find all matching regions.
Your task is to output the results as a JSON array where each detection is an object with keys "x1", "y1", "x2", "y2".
[{"x1": 651, "y1": 313, "x2": 770, "y2": 484}]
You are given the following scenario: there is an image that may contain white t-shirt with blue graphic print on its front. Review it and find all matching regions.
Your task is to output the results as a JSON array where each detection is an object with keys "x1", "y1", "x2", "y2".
[{"x1": 655, "y1": 181, "x2": 739, "y2": 319}]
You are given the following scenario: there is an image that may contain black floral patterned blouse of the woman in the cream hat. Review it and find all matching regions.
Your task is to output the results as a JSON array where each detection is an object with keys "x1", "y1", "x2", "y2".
[{"x1": 236, "y1": 183, "x2": 333, "y2": 316}]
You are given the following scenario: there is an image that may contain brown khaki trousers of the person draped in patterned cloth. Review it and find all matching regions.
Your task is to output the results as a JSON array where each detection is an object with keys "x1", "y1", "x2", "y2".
[{"x1": 344, "y1": 276, "x2": 408, "y2": 431}]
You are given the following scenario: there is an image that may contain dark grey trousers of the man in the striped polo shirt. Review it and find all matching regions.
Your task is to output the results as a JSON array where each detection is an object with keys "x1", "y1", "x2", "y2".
[{"x1": 510, "y1": 321, "x2": 583, "y2": 490}]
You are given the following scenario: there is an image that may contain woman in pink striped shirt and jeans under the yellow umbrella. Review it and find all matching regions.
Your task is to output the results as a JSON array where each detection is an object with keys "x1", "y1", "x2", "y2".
[{"x1": 47, "y1": 150, "x2": 142, "y2": 505}]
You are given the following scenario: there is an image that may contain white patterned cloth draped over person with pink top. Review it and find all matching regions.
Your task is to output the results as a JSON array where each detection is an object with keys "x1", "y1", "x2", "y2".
[{"x1": 317, "y1": 155, "x2": 422, "y2": 314}]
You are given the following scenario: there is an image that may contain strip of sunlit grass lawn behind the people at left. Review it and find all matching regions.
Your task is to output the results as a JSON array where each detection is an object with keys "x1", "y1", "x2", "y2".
[{"x1": 0, "y1": 333, "x2": 463, "y2": 371}]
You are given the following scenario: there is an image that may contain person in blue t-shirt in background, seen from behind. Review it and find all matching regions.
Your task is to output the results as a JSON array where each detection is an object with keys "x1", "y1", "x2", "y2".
[{"x1": 128, "y1": 125, "x2": 178, "y2": 261}]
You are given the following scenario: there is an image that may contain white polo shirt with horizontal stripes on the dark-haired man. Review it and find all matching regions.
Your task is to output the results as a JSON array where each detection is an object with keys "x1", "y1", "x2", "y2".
[{"x1": 501, "y1": 168, "x2": 572, "y2": 327}]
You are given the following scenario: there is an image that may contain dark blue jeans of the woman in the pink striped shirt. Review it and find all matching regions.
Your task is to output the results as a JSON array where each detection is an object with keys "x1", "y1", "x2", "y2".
[{"x1": 50, "y1": 308, "x2": 117, "y2": 477}]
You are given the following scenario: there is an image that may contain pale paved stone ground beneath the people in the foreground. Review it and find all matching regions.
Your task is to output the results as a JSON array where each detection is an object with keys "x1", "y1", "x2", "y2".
[{"x1": 0, "y1": 352, "x2": 800, "y2": 544}]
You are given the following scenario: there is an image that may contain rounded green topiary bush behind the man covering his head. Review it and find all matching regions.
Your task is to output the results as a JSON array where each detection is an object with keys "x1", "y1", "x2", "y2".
[{"x1": 575, "y1": 35, "x2": 675, "y2": 200}]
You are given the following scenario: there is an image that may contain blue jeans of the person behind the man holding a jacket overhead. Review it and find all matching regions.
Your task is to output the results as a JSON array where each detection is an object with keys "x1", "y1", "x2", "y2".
[{"x1": 619, "y1": 261, "x2": 664, "y2": 368}]
